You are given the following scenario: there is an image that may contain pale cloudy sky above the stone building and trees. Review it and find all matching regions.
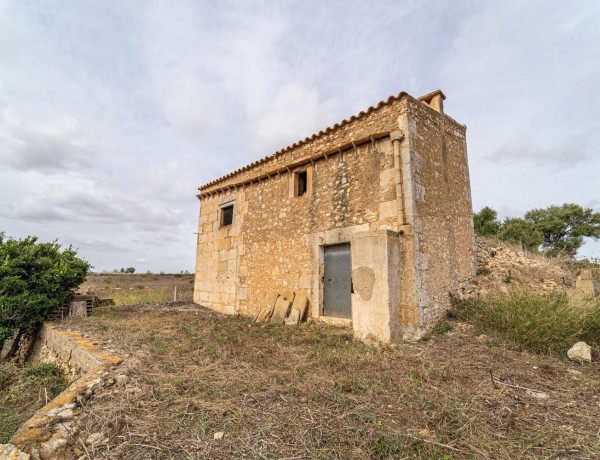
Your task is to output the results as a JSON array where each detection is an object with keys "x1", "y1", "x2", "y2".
[{"x1": 0, "y1": 0, "x2": 600, "y2": 272}]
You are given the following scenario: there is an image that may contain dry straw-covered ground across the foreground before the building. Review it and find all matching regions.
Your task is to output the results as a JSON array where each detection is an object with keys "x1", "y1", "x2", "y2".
[{"x1": 58, "y1": 303, "x2": 600, "y2": 459}]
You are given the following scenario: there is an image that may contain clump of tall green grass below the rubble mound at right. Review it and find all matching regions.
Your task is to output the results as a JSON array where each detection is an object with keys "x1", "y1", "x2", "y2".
[{"x1": 452, "y1": 291, "x2": 600, "y2": 354}]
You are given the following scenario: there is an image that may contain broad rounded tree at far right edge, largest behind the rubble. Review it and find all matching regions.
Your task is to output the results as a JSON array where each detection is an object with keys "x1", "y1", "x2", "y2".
[{"x1": 525, "y1": 203, "x2": 600, "y2": 256}]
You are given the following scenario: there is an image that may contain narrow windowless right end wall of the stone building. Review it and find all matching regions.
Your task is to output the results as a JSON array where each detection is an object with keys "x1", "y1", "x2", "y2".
[{"x1": 407, "y1": 101, "x2": 475, "y2": 336}]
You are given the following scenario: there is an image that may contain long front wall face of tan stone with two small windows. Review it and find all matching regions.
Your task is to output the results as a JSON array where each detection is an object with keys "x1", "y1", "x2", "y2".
[{"x1": 194, "y1": 137, "x2": 398, "y2": 316}]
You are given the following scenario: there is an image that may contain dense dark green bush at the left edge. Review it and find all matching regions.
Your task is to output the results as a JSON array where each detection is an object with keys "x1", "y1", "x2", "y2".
[{"x1": 0, "y1": 237, "x2": 90, "y2": 348}]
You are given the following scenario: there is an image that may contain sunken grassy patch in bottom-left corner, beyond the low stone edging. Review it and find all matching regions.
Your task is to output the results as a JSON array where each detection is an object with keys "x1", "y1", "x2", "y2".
[{"x1": 0, "y1": 362, "x2": 68, "y2": 444}]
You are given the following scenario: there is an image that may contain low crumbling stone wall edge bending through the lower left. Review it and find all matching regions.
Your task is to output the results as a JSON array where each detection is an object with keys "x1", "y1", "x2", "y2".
[{"x1": 9, "y1": 324, "x2": 123, "y2": 460}]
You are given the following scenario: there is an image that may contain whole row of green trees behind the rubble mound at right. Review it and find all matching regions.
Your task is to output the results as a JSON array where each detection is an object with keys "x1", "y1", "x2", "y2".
[{"x1": 473, "y1": 203, "x2": 600, "y2": 257}]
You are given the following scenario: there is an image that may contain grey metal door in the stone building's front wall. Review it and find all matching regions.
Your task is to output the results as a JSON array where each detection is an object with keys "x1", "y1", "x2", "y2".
[{"x1": 323, "y1": 243, "x2": 352, "y2": 318}]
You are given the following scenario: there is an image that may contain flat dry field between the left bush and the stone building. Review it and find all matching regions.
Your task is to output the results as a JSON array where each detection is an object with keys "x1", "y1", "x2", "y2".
[{"x1": 79, "y1": 273, "x2": 194, "y2": 305}]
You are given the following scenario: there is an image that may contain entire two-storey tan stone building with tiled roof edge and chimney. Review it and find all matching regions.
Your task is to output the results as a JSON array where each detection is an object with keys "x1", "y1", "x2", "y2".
[{"x1": 194, "y1": 91, "x2": 475, "y2": 342}]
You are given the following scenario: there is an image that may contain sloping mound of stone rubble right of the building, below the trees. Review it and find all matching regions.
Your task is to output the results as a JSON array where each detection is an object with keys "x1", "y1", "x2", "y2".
[{"x1": 455, "y1": 237, "x2": 575, "y2": 299}]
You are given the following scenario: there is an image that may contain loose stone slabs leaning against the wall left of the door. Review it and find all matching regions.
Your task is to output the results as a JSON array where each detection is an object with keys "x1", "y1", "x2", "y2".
[{"x1": 254, "y1": 291, "x2": 308, "y2": 326}]
